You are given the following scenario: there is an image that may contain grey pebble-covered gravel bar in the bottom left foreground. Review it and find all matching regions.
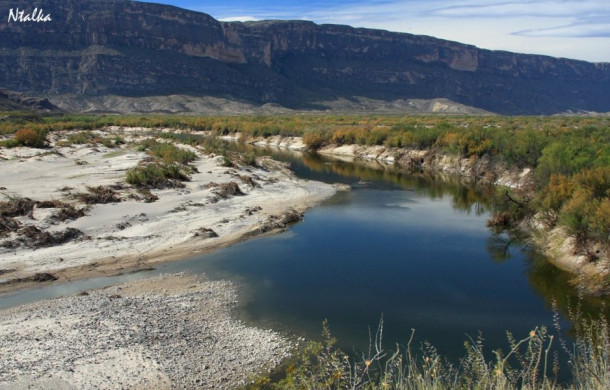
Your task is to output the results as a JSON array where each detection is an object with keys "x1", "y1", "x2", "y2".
[{"x1": 0, "y1": 274, "x2": 291, "y2": 389}]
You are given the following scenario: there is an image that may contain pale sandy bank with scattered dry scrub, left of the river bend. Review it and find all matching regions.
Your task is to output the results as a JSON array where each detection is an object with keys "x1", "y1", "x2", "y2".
[{"x1": 0, "y1": 128, "x2": 335, "y2": 291}]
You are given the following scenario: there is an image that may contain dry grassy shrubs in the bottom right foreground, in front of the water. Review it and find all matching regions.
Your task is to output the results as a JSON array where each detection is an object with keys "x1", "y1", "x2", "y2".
[{"x1": 248, "y1": 314, "x2": 610, "y2": 390}]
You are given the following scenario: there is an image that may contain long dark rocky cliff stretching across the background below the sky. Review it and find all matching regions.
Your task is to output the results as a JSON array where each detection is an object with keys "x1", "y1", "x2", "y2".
[{"x1": 0, "y1": 0, "x2": 610, "y2": 114}]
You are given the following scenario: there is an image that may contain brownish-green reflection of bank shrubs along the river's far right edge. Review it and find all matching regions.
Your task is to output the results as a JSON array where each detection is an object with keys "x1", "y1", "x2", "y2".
[{"x1": 239, "y1": 140, "x2": 610, "y2": 326}]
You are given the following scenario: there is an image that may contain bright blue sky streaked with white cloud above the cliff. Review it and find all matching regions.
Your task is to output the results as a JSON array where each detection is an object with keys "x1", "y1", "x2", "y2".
[{"x1": 144, "y1": 0, "x2": 610, "y2": 62}]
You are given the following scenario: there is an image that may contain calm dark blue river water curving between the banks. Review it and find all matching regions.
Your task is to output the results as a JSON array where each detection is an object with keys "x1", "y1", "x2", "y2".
[{"x1": 0, "y1": 144, "x2": 594, "y2": 366}]
